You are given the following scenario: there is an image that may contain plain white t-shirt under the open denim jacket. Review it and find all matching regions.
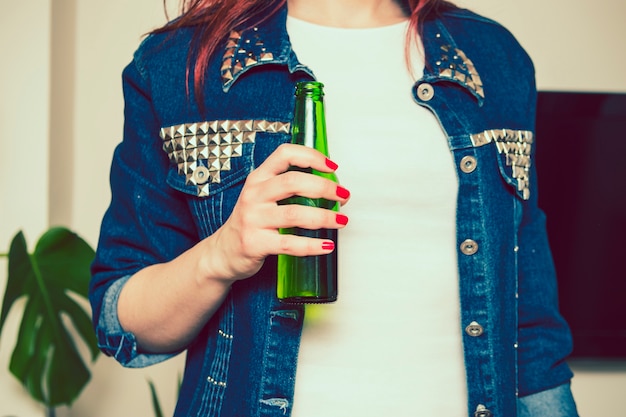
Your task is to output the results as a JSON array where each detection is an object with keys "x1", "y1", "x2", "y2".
[{"x1": 287, "y1": 17, "x2": 467, "y2": 417}]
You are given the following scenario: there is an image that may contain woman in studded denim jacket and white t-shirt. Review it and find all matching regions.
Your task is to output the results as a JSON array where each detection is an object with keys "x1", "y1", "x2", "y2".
[{"x1": 91, "y1": 0, "x2": 576, "y2": 417}]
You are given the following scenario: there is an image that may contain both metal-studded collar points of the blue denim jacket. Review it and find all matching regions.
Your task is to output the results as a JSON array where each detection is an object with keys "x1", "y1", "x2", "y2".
[{"x1": 221, "y1": 6, "x2": 485, "y2": 104}]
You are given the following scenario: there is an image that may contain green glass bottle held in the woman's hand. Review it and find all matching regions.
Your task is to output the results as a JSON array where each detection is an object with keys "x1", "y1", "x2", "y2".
[{"x1": 277, "y1": 81, "x2": 339, "y2": 304}]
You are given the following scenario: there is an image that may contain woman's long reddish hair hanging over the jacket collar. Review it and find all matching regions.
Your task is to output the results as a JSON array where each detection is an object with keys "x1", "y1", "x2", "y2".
[{"x1": 153, "y1": 0, "x2": 451, "y2": 98}]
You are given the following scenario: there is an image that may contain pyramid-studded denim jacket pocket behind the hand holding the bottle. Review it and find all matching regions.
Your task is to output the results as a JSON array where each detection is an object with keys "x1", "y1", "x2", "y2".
[{"x1": 160, "y1": 120, "x2": 290, "y2": 237}]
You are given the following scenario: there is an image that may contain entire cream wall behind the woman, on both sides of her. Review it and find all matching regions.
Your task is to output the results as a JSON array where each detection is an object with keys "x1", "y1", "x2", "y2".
[{"x1": 0, "y1": 0, "x2": 626, "y2": 417}]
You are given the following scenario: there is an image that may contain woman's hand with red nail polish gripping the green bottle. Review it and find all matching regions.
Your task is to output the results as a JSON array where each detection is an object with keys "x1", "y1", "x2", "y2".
[{"x1": 210, "y1": 144, "x2": 349, "y2": 281}]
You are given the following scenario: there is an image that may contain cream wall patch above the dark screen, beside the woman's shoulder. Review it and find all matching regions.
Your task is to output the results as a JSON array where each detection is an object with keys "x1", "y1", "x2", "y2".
[{"x1": 457, "y1": 0, "x2": 626, "y2": 92}]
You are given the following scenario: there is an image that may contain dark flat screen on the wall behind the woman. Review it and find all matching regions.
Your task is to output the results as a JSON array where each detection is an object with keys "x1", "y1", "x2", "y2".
[{"x1": 534, "y1": 92, "x2": 626, "y2": 359}]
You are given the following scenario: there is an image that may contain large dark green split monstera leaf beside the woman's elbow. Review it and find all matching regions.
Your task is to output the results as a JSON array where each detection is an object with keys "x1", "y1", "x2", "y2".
[{"x1": 0, "y1": 227, "x2": 98, "y2": 407}]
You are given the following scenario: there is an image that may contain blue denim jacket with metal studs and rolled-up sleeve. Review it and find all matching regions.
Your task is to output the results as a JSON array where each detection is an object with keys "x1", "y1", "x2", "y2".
[{"x1": 90, "y1": 4, "x2": 572, "y2": 417}]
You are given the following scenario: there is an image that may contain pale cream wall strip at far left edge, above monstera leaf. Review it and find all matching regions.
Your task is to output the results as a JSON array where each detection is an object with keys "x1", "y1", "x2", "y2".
[{"x1": 0, "y1": 0, "x2": 50, "y2": 417}]
